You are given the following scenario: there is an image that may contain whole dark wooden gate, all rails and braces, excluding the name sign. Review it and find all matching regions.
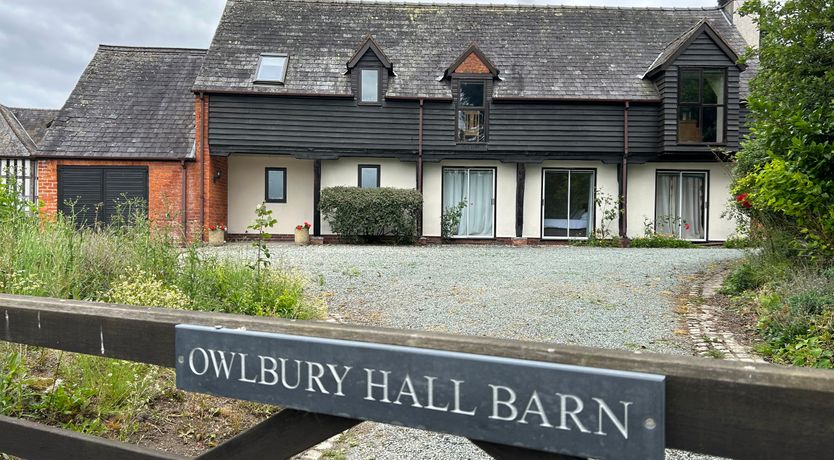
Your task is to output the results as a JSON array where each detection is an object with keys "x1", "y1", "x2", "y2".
[{"x1": 0, "y1": 295, "x2": 834, "y2": 459}]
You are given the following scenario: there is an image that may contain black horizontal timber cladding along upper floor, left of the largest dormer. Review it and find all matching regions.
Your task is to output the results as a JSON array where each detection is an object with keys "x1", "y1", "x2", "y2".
[{"x1": 209, "y1": 94, "x2": 660, "y2": 162}]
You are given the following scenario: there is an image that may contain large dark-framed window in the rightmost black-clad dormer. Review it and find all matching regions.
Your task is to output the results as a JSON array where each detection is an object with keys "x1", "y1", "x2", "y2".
[{"x1": 678, "y1": 69, "x2": 727, "y2": 144}]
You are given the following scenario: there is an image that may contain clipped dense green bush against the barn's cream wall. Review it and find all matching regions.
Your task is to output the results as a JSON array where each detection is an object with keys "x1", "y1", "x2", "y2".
[{"x1": 320, "y1": 187, "x2": 423, "y2": 244}]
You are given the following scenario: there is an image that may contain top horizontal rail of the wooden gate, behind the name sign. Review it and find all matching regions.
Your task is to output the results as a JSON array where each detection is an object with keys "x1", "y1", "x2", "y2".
[{"x1": 0, "y1": 295, "x2": 834, "y2": 459}]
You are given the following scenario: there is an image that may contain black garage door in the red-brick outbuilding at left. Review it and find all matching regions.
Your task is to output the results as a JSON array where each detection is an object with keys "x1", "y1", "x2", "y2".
[{"x1": 58, "y1": 166, "x2": 148, "y2": 226}]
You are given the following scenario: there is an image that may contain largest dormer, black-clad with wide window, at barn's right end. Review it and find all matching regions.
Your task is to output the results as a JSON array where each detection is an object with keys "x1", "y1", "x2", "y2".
[{"x1": 643, "y1": 19, "x2": 745, "y2": 156}]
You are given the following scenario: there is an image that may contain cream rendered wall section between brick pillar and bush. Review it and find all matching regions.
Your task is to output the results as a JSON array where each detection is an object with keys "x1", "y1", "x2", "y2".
[{"x1": 228, "y1": 154, "x2": 313, "y2": 234}]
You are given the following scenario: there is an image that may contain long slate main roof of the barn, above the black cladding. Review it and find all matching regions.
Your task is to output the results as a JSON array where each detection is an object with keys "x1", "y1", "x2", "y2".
[{"x1": 194, "y1": 0, "x2": 746, "y2": 100}]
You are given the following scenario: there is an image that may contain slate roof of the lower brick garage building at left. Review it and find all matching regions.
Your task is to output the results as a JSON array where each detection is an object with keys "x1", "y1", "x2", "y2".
[{"x1": 40, "y1": 45, "x2": 205, "y2": 160}]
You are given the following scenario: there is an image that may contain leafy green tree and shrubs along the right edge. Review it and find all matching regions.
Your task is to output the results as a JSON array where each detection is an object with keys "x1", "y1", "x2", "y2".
[{"x1": 723, "y1": 0, "x2": 834, "y2": 368}]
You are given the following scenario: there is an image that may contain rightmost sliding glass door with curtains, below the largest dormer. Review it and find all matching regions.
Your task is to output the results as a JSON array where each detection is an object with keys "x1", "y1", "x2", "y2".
[{"x1": 654, "y1": 171, "x2": 707, "y2": 240}]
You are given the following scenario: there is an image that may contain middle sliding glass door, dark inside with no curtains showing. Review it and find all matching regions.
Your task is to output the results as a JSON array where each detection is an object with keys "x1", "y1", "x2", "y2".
[{"x1": 542, "y1": 169, "x2": 596, "y2": 239}]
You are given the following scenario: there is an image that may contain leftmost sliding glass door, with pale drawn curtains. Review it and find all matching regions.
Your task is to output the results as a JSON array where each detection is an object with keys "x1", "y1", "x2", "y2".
[{"x1": 443, "y1": 168, "x2": 495, "y2": 238}]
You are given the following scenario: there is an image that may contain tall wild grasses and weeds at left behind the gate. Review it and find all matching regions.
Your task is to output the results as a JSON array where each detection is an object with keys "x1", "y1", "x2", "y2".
[{"x1": 0, "y1": 180, "x2": 321, "y2": 438}]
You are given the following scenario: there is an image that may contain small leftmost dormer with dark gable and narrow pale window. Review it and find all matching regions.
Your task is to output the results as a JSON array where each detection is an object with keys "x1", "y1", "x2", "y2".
[{"x1": 347, "y1": 35, "x2": 394, "y2": 105}]
